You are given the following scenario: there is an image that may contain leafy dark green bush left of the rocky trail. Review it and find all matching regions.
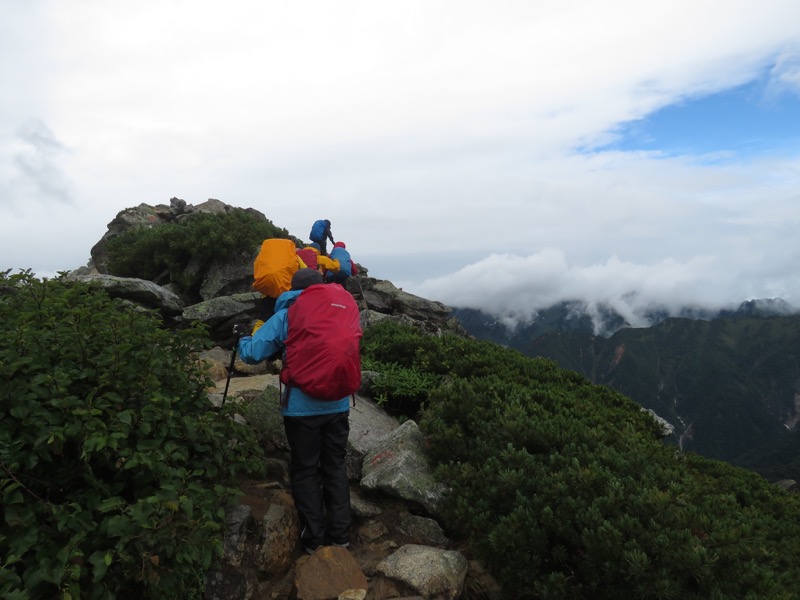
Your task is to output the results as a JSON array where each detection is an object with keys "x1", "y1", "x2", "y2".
[{"x1": 0, "y1": 273, "x2": 260, "y2": 599}]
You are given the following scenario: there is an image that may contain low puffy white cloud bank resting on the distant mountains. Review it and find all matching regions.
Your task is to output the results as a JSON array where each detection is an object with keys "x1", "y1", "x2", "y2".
[{"x1": 413, "y1": 248, "x2": 784, "y2": 333}]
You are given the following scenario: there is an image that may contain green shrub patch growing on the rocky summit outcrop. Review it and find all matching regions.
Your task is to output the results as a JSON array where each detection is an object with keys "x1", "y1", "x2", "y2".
[{"x1": 108, "y1": 208, "x2": 290, "y2": 294}]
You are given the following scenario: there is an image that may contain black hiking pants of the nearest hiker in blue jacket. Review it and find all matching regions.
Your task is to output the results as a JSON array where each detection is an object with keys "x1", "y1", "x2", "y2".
[{"x1": 283, "y1": 411, "x2": 351, "y2": 549}]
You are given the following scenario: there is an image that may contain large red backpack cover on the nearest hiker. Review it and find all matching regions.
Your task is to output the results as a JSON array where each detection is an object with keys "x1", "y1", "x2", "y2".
[{"x1": 281, "y1": 284, "x2": 361, "y2": 400}]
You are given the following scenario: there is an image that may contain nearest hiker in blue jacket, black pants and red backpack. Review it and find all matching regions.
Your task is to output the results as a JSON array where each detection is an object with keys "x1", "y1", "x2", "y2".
[{"x1": 234, "y1": 269, "x2": 361, "y2": 553}]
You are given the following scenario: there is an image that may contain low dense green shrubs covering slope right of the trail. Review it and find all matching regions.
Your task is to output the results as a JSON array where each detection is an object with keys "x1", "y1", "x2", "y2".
[{"x1": 364, "y1": 324, "x2": 800, "y2": 600}]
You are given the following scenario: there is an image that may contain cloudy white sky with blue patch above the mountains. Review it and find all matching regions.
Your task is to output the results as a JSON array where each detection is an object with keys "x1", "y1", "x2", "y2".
[{"x1": 0, "y1": 0, "x2": 800, "y2": 322}]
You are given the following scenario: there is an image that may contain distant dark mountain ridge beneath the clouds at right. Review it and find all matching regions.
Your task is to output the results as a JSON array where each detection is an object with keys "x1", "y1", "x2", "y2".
[{"x1": 455, "y1": 300, "x2": 800, "y2": 479}]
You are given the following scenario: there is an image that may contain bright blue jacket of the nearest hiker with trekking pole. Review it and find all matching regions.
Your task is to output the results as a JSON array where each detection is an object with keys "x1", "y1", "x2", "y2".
[{"x1": 239, "y1": 290, "x2": 350, "y2": 417}]
